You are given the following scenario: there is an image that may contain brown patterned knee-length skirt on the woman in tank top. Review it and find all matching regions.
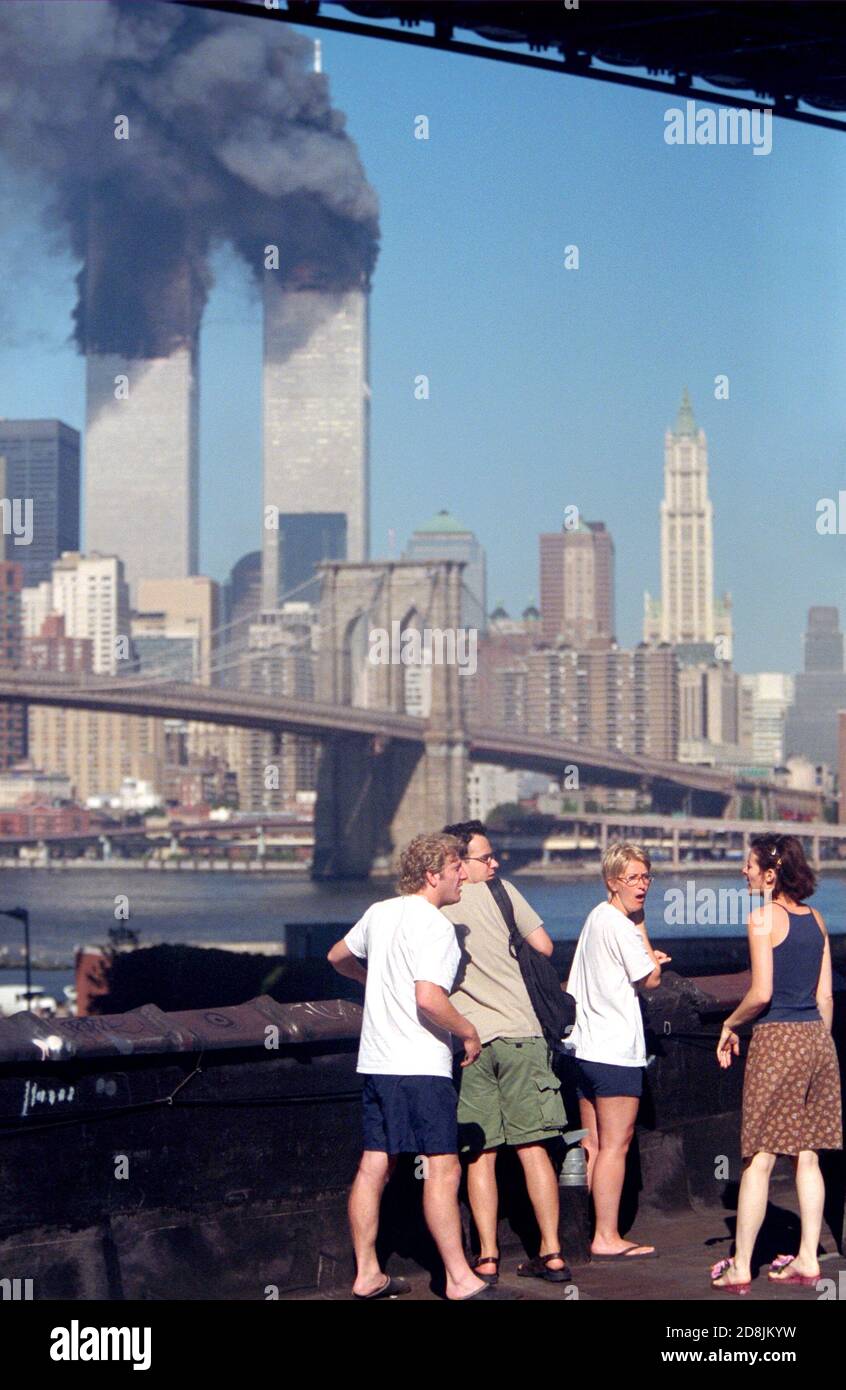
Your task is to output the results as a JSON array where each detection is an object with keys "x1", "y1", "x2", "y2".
[{"x1": 740, "y1": 1023, "x2": 843, "y2": 1158}]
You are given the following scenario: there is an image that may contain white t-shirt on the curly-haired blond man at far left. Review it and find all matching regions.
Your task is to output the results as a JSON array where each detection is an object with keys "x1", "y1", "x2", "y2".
[{"x1": 343, "y1": 894, "x2": 461, "y2": 1076}]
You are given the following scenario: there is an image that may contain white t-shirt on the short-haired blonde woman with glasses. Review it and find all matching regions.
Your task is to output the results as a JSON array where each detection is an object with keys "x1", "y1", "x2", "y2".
[{"x1": 567, "y1": 902, "x2": 654, "y2": 1066}]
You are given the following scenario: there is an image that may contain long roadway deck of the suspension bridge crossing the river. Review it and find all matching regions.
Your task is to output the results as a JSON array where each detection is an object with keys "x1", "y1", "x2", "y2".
[{"x1": 0, "y1": 671, "x2": 818, "y2": 806}]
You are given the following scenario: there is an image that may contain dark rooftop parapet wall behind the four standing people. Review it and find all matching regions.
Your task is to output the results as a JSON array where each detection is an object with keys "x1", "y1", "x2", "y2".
[{"x1": 0, "y1": 972, "x2": 846, "y2": 1300}]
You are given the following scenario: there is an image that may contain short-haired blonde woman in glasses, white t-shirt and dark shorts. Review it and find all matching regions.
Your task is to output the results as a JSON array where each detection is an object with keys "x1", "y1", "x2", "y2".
[{"x1": 567, "y1": 842, "x2": 670, "y2": 1262}]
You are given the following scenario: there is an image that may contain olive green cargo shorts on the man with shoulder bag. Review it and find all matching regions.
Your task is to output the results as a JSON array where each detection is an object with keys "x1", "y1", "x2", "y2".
[{"x1": 458, "y1": 1038, "x2": 567, "y2": 1154}]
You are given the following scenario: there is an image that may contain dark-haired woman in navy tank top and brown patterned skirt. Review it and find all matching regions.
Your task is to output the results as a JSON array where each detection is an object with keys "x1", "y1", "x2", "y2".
[{"x1": 711, "y1": 835, "x2": 843, "y2": 1294}]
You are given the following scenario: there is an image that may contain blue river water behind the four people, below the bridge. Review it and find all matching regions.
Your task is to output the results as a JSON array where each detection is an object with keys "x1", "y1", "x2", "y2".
[{"x1": 0, "y1": 869, "x2": 846, "y2": 994}]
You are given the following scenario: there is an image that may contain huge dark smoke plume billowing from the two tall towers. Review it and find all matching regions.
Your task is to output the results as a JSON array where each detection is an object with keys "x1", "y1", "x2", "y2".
[{"x1": 0, "y1": 0, "x2": 378, "y2": 357}]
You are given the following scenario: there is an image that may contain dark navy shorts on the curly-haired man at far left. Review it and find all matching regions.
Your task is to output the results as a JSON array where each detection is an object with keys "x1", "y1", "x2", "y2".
[{"x1": 361, "y1": 1076, "x2": 458, "y2": 1154}]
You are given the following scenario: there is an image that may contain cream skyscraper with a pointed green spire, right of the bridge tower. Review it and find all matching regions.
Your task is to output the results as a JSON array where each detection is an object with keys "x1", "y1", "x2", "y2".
[{"x1": 643, "y1": 388, "x2": 732, "y2": 660}]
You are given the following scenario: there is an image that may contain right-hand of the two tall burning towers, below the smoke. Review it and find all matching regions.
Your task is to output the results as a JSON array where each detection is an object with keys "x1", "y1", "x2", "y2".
[{"x1": 261, "y1": 274, "x2": 370, "y2": 610}]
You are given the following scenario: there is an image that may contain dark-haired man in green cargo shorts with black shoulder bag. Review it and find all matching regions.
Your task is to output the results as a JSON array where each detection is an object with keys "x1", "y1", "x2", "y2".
[{"x1": 442, "y1": 820, "x2": 572, "y2": 1284}]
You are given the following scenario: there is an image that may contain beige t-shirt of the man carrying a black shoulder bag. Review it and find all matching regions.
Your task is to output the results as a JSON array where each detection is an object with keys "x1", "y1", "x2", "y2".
[{"x1": 440, "y1": 878, "x2": 543, "y2": 1043}]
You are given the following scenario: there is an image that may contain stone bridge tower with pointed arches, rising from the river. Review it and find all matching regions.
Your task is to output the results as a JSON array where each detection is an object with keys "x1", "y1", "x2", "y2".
[{"x1": 314, "y1": 560, "x2": 467, "y2": 877}]
